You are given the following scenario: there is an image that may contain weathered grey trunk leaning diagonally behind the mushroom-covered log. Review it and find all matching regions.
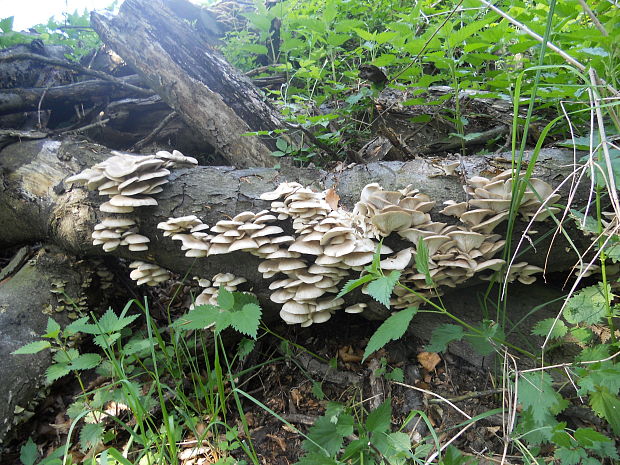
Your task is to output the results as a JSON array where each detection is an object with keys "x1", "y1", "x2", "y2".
[{"x1": 91, "y1": 0, "x2": 283, "y2": 168}]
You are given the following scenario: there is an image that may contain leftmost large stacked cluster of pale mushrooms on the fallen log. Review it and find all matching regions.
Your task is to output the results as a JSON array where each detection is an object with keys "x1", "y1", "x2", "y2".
[{"x1": 66, "y1": 150, "x2": 198, "y2": 252}]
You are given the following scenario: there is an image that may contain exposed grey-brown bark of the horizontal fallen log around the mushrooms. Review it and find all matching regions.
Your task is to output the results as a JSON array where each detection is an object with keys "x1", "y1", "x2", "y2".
[{"x1": 0, "y1": 136, "x2": 585, "y2": 283}]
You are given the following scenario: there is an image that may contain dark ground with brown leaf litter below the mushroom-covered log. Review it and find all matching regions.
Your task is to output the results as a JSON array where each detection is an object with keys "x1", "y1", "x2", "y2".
[{"x1": 0, "y1": 296, "x2": 517, "y2": 465}]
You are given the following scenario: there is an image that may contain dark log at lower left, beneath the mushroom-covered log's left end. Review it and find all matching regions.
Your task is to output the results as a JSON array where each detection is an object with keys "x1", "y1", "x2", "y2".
[{"x1": 0, "y1": 247, "x2": 112, "y2": 442}]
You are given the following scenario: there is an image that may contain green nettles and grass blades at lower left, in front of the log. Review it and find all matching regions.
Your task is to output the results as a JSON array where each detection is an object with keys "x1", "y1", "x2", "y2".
[{"x1": 13, "y1": 287, "x2": 261, "y2": 465}]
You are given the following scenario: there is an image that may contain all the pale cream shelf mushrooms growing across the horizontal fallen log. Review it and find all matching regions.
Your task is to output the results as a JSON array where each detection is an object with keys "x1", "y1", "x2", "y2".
[{"x1": 69, "y1": 151, "x2": 559, "y2": 326}]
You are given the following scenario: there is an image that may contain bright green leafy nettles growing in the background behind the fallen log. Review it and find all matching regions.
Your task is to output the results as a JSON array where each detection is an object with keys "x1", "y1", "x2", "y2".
[{"x1": 223, "y1": 0, "x2": 620, "y2": 158}]
